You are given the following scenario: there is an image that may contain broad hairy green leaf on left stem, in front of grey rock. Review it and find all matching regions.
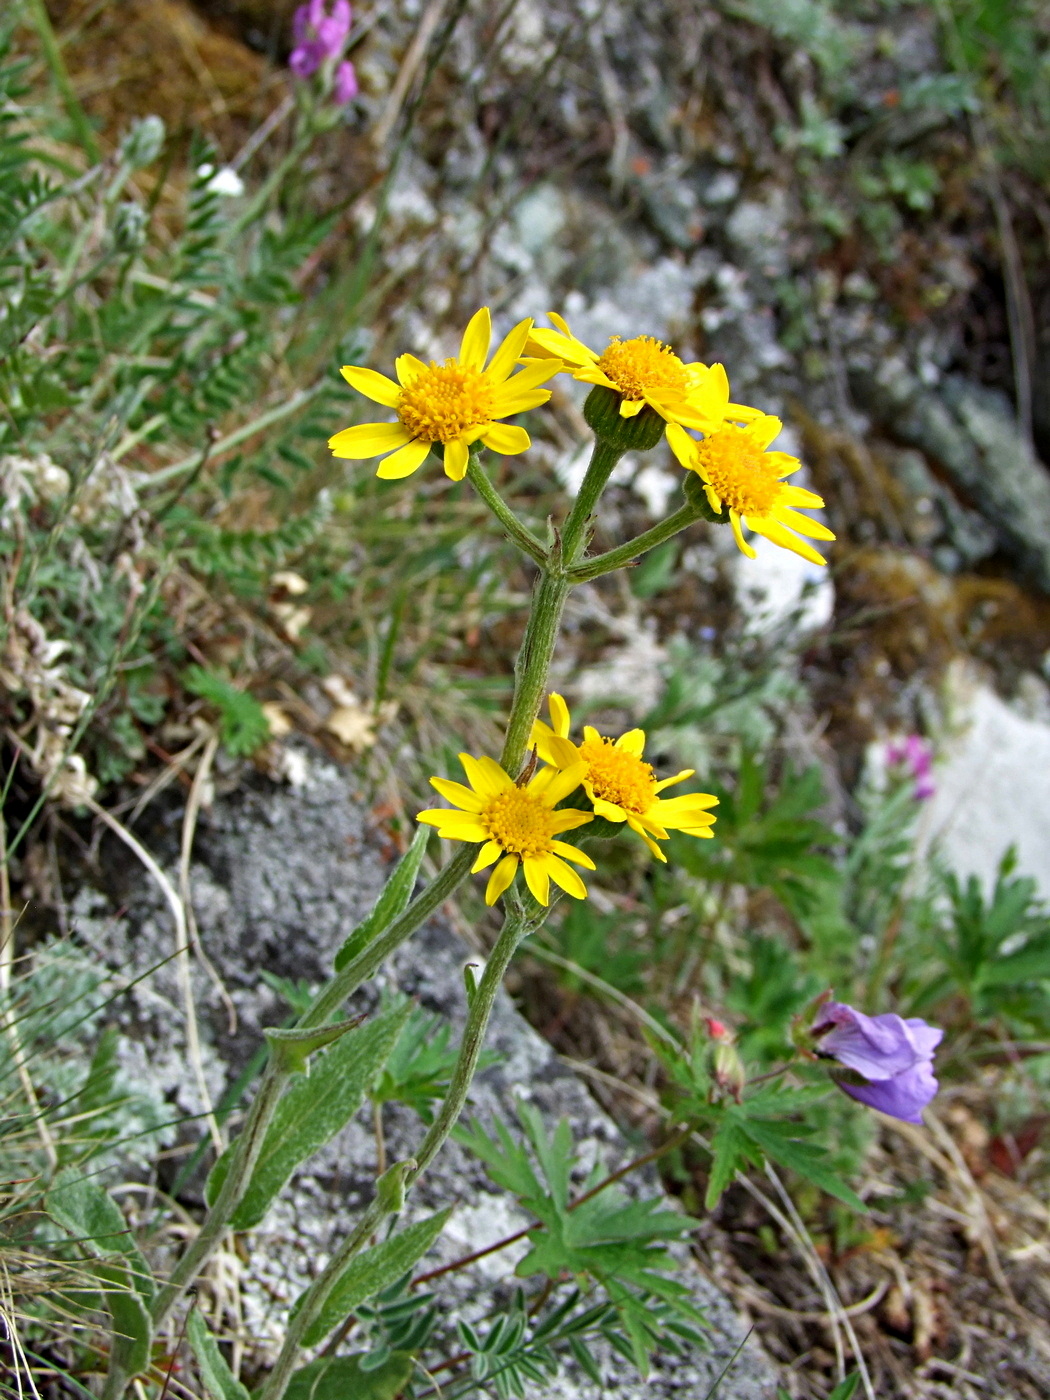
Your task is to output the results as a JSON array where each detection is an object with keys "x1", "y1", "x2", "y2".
[{"x1": 204, "y1": 1001, "x2": 410, "y2": 1229}]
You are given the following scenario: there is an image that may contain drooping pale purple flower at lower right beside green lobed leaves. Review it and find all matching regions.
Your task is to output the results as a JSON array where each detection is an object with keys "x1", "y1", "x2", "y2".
[{"x1": 812, "y1": 1001, "x2": 944, "y2": 1123}]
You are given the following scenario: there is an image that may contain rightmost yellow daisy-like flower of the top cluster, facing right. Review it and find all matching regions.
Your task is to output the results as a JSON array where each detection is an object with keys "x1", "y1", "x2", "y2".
[{"x1": 668, "y1": 413, "x2": 834, "y2": 564}]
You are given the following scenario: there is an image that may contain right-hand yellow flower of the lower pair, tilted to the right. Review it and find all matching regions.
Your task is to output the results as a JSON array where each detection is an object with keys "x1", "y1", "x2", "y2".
[{"x1": 529, "y1": 694, "x2": 718, "y2": 862}]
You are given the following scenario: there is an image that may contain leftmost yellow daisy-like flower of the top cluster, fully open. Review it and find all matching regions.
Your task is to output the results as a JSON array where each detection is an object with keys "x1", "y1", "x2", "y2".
[{"x1": 328, "y1": 307, "x2": 561, "y2": 482}]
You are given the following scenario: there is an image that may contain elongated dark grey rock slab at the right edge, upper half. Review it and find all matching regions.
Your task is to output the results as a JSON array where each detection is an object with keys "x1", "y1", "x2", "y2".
[{"x1": 851, "y1": 360, "x2": 1050, "y2": 592}]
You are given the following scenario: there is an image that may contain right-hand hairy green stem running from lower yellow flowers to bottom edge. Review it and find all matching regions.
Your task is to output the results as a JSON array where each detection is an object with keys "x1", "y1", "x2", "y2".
[{"x1": 259, "y1": 904, "x2": 546, "y2": 1400}]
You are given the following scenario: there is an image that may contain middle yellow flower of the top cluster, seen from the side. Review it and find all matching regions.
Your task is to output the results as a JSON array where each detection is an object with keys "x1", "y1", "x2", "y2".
[{"x1": 525, "y1": 311, "x2": 759, "y2": 433}]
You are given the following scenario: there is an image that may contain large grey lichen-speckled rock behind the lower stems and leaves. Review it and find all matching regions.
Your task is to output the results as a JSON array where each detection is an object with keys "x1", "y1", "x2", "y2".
[{"x1": 77, "y1": 760, "x2": 776, "y2": 1400}]
